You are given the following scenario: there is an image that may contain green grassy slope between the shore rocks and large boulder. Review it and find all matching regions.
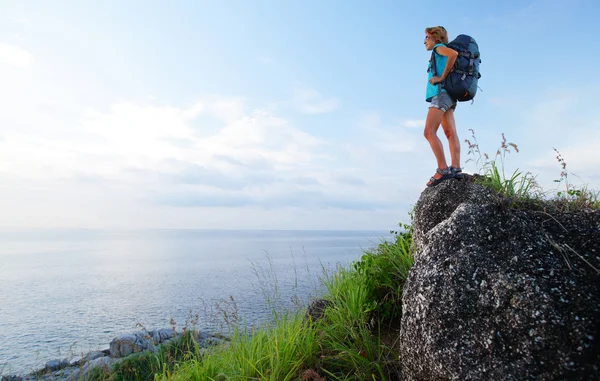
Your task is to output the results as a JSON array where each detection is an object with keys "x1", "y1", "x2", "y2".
[{"x1": 85, "y1": 221, "x2": 413, "y2": 381}]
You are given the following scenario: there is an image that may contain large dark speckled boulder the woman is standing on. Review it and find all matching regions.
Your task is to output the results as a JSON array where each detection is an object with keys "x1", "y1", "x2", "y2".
[{"x1": 400, "y1": 177, "x2": 600, "y2": 381}]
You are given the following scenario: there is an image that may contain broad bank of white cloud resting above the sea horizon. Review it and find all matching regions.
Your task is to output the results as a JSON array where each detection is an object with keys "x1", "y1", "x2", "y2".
[{"x1": 0, "y1": 93, "x2": 418, "y2": 228}]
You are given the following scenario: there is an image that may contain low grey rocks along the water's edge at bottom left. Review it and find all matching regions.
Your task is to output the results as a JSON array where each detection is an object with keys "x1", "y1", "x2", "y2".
[{"x1": 0, "y1": 328, "x2": 227, "y2": 381}]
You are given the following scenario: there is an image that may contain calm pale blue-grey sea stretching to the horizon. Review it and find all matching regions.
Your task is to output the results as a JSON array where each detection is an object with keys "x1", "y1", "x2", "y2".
[{"x1": 0, "y1": 229, "x2": 390, "y2": 375}]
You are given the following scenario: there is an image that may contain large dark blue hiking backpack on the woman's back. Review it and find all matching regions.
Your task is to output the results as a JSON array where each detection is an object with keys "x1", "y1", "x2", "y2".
[{"x1": 431, "y1": 34, "x2": 481, "y2": 102}]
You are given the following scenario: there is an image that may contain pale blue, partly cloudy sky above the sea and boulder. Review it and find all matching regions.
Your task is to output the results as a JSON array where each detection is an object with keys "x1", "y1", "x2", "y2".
[{"x1": 0, "y1": 0, "x2": 600, "y2": 231}]
